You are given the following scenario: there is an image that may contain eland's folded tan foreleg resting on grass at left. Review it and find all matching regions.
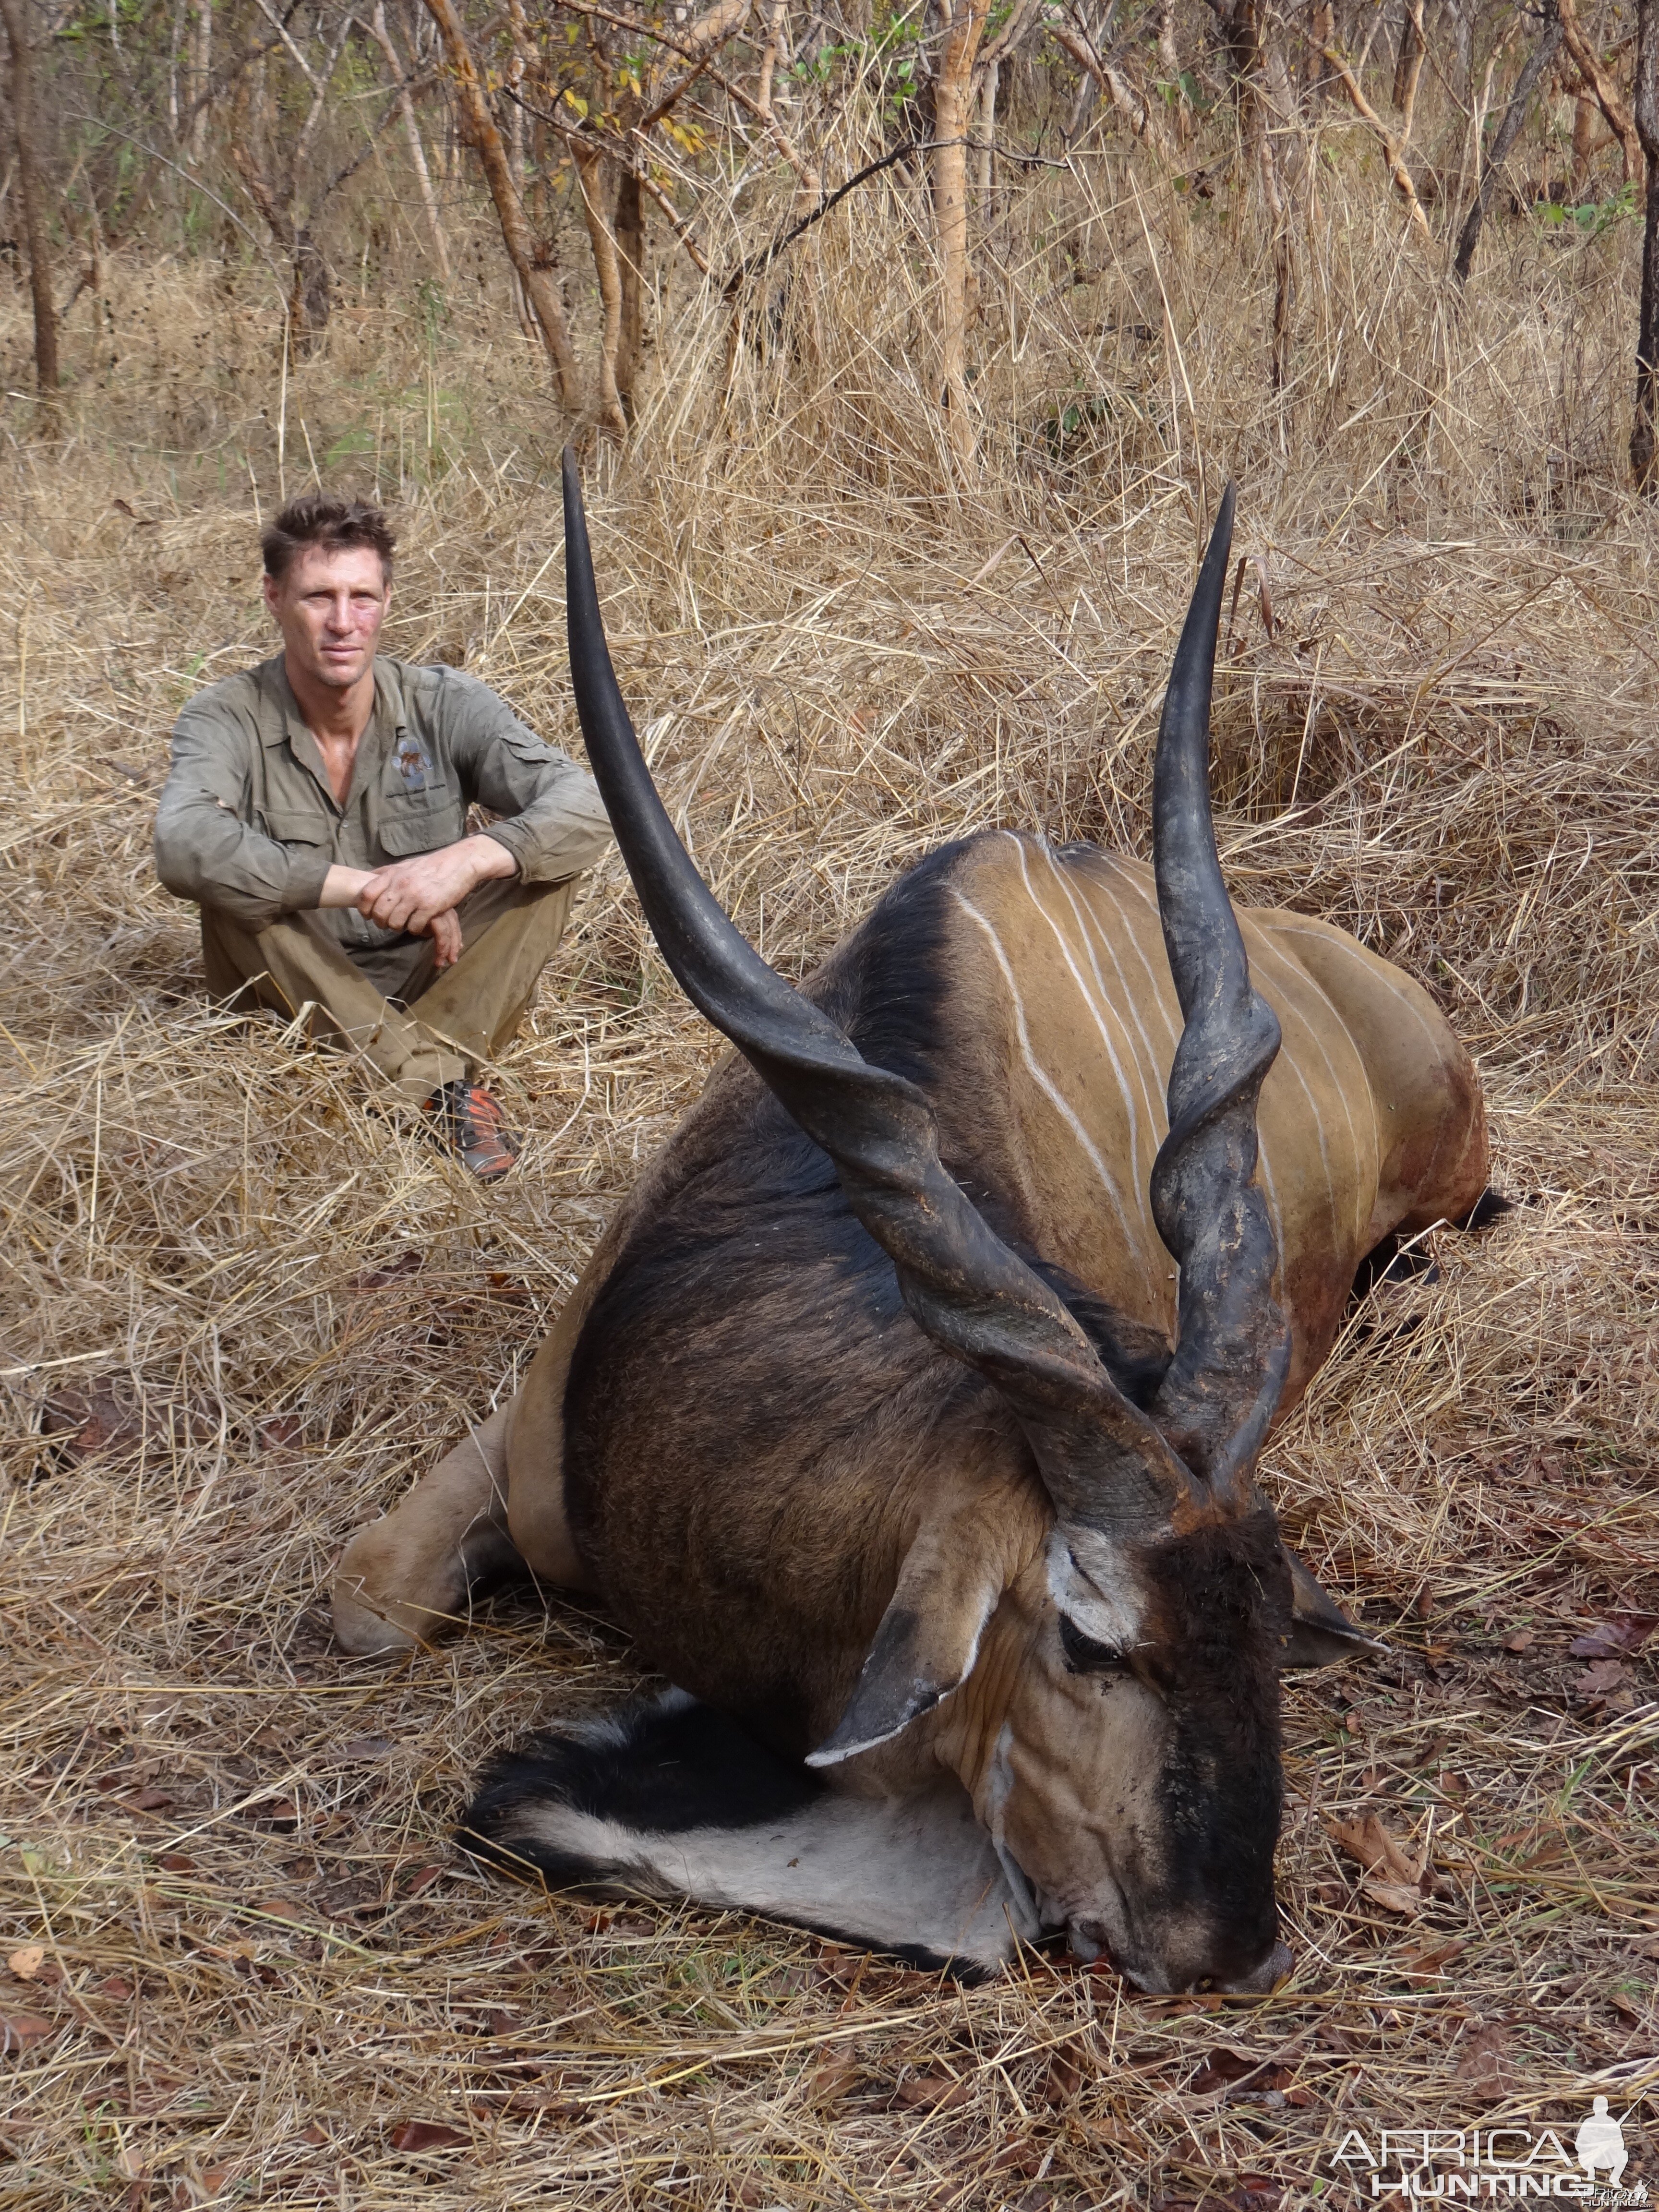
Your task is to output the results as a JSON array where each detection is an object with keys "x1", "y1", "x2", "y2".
[{"x1": 334, "y1": 1405, "x2": 522, "y2": 1657}]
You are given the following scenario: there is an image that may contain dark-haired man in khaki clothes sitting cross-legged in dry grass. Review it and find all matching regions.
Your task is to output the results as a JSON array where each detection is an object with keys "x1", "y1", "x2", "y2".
[{"x1": 155, "y1": 495, "x2": 611, "y2": 1177}]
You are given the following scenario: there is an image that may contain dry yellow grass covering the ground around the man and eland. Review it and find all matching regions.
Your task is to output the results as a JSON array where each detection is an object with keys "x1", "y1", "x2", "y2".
[{"x1": 0, "y1": 128, "x2": 1659, "y2": 2212}]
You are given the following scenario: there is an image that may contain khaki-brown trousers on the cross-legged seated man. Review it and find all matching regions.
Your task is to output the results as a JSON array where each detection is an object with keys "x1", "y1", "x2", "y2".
[{"x1": 201, "y1": 876, "x2": 577, "y2": 1104}]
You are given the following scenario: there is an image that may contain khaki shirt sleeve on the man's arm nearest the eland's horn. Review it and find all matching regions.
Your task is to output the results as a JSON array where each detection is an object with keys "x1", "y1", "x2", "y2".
[{"x1": 443, "y1": 670, "x2": 611, "y2": 883}]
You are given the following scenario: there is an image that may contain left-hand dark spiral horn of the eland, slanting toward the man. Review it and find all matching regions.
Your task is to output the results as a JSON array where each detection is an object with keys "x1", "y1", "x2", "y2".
[{"x1": 564, "y1": 449, "x2": 1192, "y2": 1528}]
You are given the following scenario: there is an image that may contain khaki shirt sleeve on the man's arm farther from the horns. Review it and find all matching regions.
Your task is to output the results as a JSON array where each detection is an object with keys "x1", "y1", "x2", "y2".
[{"x1": 155, "y1": 708, "x2": 330, "y2": 929}]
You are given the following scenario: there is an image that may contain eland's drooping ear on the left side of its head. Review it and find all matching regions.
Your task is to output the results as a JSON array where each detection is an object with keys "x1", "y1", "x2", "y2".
[{"x1": 807, "y1": 1515, "x2": 1011, "y2": 1767}]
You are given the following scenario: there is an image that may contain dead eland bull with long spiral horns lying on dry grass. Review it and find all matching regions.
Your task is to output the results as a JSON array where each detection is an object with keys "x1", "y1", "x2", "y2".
[{"x1": 334, "y1": 460, "x2": 1487, "y2": 1991}]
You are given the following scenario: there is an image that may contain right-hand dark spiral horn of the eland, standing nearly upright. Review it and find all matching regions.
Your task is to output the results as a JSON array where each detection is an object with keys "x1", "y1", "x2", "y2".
[{"x1": 1153, "y1": 484, "x2": 1289, "y2": 1493}]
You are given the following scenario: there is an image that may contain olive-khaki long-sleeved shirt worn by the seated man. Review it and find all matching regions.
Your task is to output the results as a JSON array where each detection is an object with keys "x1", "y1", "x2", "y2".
[{"x1": 155, "y1": 652, "x2": 611, "y2": 953}]
